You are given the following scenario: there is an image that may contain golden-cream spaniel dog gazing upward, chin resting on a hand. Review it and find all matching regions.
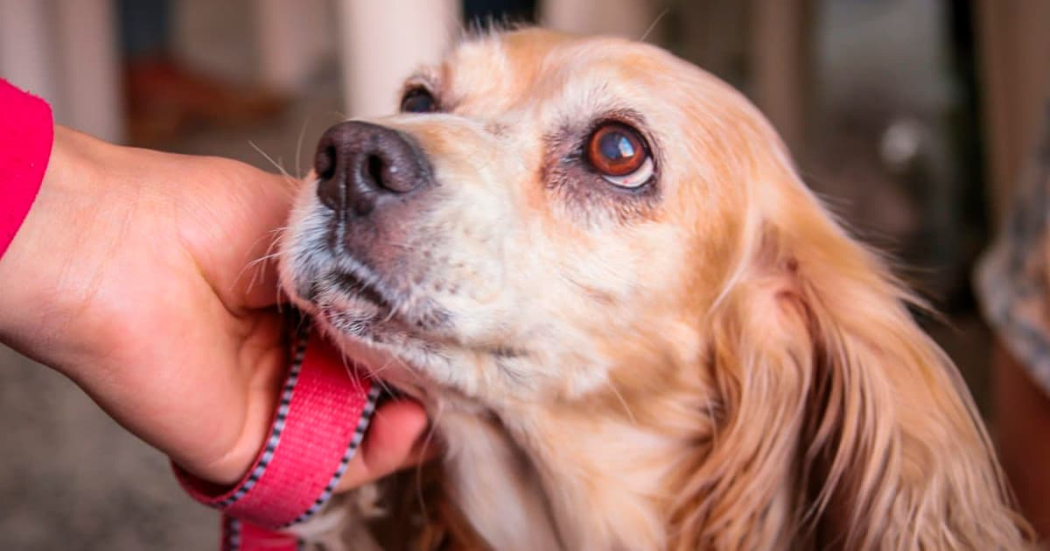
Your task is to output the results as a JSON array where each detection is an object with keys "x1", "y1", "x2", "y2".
[{"x1": 280, "y1": 28, "x2": 1033, "y2": 550}]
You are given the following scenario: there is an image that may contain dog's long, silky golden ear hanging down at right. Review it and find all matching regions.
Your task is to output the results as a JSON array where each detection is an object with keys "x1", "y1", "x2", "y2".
[{"x1": 674, "y1": 157, "x2": 1026, "y2": 549}]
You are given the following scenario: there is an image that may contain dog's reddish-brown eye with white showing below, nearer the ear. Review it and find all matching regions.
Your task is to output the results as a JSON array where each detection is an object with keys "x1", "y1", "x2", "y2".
[{"x1": 587, "y1": 123, "x2": 653, "y2": 188}]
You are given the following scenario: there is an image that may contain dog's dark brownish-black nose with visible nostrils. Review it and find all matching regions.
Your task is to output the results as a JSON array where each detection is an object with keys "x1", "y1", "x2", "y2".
[{"x1": 314, "y1": 122, "x2": 431, "y2": 216}]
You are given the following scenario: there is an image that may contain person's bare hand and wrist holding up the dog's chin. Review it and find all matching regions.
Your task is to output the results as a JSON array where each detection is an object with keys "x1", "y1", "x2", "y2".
[{"x1": 0, "y1": 127, "x2": 426, "y2": 488}]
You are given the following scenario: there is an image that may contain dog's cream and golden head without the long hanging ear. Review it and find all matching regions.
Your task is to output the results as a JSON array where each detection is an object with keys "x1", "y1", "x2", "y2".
[{"x1": 284, "y1": 30, "x2": 755, "y2": 402}]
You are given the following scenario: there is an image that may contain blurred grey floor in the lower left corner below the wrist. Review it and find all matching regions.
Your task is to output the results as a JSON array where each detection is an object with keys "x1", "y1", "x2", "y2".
[{"x1": 0, "y1": 348, "x2": 218, "y2": 551}]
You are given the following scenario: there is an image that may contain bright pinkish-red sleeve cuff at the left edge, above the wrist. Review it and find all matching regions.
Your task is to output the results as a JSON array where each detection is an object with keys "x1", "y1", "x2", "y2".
[{"x1": 0, "y1": 79, "x2": 55, "y2": 257}]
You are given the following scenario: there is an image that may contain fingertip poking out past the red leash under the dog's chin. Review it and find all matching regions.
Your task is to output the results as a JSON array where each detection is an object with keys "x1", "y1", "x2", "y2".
[{"x1": 336, "y1": 400, "x2": 435, "y2": 492}]
